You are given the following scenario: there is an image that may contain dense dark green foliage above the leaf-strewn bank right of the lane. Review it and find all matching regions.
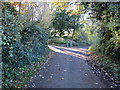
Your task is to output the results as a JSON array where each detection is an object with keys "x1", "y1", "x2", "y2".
[{"x1": 91, "y1": 3, "x2": 120, "y2": 59}]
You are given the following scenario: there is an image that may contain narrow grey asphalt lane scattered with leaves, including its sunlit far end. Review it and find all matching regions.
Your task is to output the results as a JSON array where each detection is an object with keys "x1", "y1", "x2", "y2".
[{"x1": 27, "y1": 46, "x2": 106, "y2": 88}]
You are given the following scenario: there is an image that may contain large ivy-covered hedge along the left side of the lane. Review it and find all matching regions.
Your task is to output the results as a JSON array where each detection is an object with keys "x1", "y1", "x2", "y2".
[{"x1": 2, "y1": 2, "x2": 49, "y2": 88}]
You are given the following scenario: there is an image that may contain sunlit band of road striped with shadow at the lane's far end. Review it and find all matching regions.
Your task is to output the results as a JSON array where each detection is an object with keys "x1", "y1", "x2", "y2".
[{"x1": 49, "y1": 45, "x2": 87, "y2": 59}]
